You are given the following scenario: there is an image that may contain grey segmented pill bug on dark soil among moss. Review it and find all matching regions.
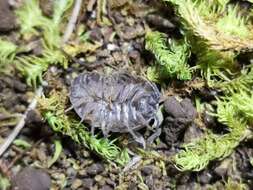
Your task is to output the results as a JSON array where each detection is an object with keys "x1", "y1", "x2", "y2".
[{"x1": 70, "y1": 72, "x2": 160, "y2": 146}]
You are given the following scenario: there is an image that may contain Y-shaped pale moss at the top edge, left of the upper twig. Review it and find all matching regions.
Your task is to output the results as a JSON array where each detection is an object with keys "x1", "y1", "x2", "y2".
[{"x1": 16, "y1": 0, "x2": 73, "y2": 49}]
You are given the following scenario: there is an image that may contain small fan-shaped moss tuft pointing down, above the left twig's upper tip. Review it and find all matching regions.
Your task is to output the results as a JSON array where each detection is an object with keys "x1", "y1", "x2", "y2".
[{"x1": 15, "y1": 56, "x2": 48, "y2": 88}]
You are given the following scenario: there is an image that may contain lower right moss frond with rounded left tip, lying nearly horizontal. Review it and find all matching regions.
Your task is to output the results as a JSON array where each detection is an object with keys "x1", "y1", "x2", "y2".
[{"x1": 174, "y1": 132, "x2": 243, "y2": 171}]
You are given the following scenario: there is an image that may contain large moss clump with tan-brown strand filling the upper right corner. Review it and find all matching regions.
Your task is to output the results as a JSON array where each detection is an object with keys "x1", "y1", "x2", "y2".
[{"x1": 164, "y1": 0, "x2": 253, "y2": 85}]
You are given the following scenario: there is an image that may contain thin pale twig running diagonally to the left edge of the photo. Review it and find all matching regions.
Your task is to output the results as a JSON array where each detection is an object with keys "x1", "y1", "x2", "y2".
[{"x1": 0, "y1": 86, "x2": 42, "y2": 157}]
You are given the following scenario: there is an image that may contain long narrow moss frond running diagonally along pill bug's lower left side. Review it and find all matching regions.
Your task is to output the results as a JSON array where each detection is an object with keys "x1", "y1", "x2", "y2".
[{"x1": 39, "y1": 90, "x2": 130, "y2": 165}]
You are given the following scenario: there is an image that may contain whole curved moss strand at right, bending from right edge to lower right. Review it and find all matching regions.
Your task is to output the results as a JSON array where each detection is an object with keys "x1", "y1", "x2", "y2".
[{"x1": 174, "y1": 92, "x2": 250, "y2": 171}]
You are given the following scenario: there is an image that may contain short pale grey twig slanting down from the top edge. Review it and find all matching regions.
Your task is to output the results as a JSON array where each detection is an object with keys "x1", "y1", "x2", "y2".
[{"x1": 62, "y1": 0, "x2": 82, "y2": 44}]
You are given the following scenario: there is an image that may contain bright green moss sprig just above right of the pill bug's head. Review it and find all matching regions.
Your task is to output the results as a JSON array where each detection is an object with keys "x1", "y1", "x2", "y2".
[{"x1": 145, "y1": 32, "x2": 191, "y2": 80}]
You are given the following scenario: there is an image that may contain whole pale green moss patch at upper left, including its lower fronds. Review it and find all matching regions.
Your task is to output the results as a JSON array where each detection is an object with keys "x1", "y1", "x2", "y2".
[{"x1": 12, "y1": 0, "x2": 73, "y2": 87}]
